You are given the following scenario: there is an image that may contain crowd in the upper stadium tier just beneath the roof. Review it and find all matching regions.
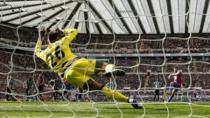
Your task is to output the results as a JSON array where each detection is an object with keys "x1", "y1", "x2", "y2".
[{"x1": 0, "y1": 26, "x2": 210, "y2": 53}]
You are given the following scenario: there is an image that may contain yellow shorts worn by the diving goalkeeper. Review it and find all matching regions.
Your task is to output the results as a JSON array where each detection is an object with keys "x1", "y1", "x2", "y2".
[{"x1": 64, "y1": 58, "x2": 96, "y2": 88}]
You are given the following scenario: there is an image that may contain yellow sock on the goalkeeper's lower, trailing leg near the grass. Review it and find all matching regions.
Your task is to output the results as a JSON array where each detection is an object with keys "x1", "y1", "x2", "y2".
[{"x1": 101, "y1": 86, "x2": 128, "y2": 102}]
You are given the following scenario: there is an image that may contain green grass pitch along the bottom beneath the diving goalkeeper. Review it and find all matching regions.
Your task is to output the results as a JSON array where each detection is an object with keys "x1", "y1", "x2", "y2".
[{"x1": 0, "y1": 102, "x2": 210, "y2": 118}]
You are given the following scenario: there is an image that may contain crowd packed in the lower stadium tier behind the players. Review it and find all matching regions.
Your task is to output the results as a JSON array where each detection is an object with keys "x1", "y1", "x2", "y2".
[{"x1": 0, "y1": 51, "x2": 210, "y2": 100}]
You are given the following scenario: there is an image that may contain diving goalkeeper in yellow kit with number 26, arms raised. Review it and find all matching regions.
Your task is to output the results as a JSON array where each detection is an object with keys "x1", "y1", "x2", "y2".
[{"x1": 35, "y1": 29, "x2": 142, "y2": 108}]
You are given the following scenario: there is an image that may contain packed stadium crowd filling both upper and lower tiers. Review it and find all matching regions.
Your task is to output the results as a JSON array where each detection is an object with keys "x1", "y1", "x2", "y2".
[{"x1": 0, "y1": 27, "x2": 210, "y2": 100}]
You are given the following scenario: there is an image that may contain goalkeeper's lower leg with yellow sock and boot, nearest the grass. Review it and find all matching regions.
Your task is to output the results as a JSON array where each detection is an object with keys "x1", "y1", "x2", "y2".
[{"x1": 83, "y1": 78, "x2": 142, "y2": 109}]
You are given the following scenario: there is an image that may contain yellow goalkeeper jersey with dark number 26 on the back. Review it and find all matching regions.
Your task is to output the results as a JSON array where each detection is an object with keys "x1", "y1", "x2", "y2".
[{"x1": 34, "y1": 29, "x2": 78, "y2": 79}]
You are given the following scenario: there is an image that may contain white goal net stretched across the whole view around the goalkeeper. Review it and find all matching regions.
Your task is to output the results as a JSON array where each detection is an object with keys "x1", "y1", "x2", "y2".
[{"x1": 0, "y1": 0, "x2": 210, "y2": 118}]
